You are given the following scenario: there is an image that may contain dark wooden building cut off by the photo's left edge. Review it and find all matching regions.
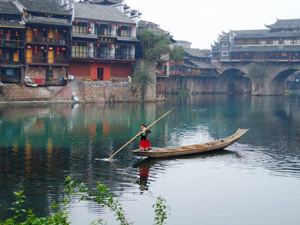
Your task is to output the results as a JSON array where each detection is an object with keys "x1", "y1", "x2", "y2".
[{"x1": 0, "y1": 0, "x2": 24, "y2": 83}]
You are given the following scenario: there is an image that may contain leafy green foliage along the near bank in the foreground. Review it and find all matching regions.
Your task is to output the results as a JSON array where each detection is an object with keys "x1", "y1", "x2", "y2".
[{"x1": 0, "y1": 177, "x2": 168, "y2": 225}]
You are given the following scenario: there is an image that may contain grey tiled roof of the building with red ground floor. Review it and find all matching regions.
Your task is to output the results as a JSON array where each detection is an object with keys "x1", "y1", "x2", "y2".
[{"x1": 75, "y1": 3, "x2": 135, "y2": 24}]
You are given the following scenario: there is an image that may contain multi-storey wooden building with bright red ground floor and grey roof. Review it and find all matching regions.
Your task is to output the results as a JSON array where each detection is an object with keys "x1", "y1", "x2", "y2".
[{"x1": 69, "y1": 3, "x2": 137, "y2": 80}]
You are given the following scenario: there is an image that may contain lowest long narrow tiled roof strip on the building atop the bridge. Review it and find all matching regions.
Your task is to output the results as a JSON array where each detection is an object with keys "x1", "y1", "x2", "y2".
[{"x1": 231, "y1": 45, "x2": 300, "y2": 52}]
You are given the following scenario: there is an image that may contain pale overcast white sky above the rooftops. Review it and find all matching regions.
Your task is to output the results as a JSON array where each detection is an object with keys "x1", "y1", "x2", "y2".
[{"x1": 125, "y1": 0, "x2": 300, "y2": 48}]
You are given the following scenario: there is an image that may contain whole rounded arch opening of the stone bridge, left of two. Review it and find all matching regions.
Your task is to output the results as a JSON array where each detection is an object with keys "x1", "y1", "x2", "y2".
[{"x1": 219, "y1": 68, "x2": 252, "y2": 94}]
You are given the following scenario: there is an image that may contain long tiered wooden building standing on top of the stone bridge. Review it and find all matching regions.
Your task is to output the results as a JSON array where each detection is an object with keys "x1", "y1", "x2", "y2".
[{"x1": 212, "y1": 19, "x2": 300, "y2": 63}]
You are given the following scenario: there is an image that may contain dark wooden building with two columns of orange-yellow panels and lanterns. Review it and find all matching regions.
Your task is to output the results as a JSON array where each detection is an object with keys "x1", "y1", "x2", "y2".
[{"x1": 16, "y1": 0, "x2": 72, "y2": 85}]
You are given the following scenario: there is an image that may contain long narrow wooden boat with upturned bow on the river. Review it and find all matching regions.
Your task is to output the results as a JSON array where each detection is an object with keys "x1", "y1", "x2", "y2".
[{"x1": 131, "y1": 129, "x2": 248, "y2": 158}]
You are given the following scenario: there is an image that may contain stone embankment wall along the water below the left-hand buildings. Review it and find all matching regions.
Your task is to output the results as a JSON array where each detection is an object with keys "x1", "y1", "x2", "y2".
[{"x1": 0, "y1": 80, "x2": 157, "y2": 103}]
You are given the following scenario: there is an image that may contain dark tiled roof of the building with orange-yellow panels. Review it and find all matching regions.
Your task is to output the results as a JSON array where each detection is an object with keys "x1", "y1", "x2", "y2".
[{"x1": 18, "y1": 0, "x2": 71, "y2": 15}]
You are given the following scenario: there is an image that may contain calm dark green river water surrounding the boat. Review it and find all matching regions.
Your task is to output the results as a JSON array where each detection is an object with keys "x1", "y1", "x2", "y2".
[{"x1": 0, "y1": 95, "x2": 300, "y2": 225}]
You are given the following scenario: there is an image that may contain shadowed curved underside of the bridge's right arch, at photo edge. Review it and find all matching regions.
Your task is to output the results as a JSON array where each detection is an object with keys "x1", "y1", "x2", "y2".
[{"x1": 271, "y1": 68, "x2": 299, "y2": 95}]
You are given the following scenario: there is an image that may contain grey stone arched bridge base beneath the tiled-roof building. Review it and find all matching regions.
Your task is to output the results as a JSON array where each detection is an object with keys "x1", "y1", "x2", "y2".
[{"x1": 215, "y1": 62, "x2": 300, "y2": 95}]
